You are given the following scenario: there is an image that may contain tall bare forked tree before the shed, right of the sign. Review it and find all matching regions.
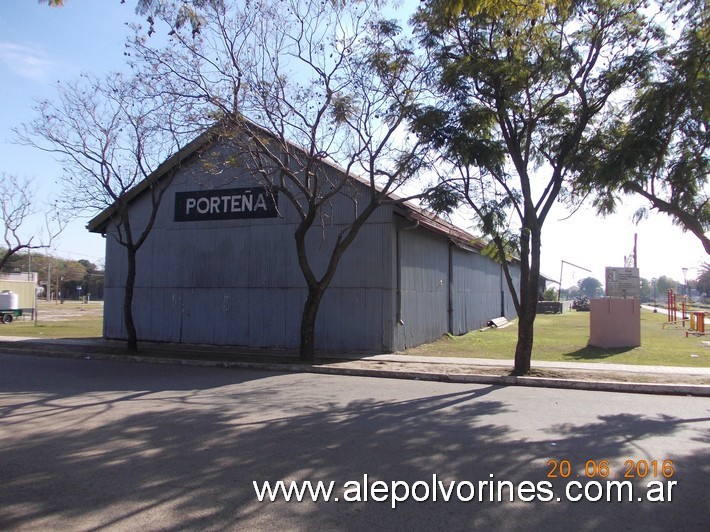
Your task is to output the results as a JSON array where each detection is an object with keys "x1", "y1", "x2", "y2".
[{"x1": 132, "y1": 0, "x2": 434, "y2": 361}]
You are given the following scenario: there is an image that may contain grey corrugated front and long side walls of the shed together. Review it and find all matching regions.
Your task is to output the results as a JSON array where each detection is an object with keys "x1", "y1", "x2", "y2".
[{"x1": 104, "y1": 138, "x2": 514, "y2": 351}]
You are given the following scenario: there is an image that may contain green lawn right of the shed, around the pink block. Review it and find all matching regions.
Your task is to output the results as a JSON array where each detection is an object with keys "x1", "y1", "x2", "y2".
[{"x1": 405, "y1": 310, "x2": 710, "y2": 367}]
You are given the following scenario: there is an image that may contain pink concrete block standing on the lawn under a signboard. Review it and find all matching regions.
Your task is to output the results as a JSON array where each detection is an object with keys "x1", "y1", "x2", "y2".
[{"x1": 589, "y1": 298, "x2": 641, "y2": 349}]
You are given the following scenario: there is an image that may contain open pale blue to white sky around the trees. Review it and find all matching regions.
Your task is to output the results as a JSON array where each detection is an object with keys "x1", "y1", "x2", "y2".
[{"x1": 0, "y1": 0, "x2": 710, "y2": 287}]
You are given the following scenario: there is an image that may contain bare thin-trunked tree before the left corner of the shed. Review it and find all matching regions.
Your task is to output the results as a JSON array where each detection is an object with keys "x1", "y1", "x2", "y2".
[{"x1": 17, "y1": 74, "x2": 195, "y2": 351}]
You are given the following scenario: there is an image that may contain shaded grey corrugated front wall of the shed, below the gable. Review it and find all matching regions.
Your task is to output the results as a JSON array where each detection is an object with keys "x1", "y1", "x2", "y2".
[{"x1": 104, "y1": 152, "x2": 394, "y2": 351}]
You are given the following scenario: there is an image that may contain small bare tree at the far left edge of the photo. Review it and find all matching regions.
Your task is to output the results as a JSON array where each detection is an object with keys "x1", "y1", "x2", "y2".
[{"x1": 0, "y1": 173, "x2": 67, "y2": 270}]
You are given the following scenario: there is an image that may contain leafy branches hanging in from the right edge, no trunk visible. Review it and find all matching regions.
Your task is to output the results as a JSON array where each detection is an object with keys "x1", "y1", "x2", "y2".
[{"x1": 578, "y1": 0, "x2": 710, "y2": 254}]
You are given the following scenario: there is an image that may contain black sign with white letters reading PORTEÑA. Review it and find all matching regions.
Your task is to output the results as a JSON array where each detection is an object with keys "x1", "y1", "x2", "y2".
[{"x1": 175, "y1": 187, "x2": 278, "y2": 222}]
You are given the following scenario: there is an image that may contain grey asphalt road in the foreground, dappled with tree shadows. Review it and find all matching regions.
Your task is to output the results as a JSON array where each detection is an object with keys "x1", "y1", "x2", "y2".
[{"x1": 0, "y1": 356, "x2": 710, "y2": 531}]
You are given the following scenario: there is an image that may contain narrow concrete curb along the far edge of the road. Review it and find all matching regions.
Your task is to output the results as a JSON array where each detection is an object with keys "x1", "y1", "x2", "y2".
[{"x1": 6, "y1": 350, "x2": 710, "y2": 397}]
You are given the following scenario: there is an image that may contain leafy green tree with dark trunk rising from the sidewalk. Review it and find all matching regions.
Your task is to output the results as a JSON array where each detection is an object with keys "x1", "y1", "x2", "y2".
[{"x1": 414, "y1": 0, "x2": 657, "y2": 374}]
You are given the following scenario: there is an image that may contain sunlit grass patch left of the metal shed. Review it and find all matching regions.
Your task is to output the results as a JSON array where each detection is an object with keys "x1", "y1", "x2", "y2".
[{"x1": 0, "y1": 301, "x2": 103, "y2": 339}]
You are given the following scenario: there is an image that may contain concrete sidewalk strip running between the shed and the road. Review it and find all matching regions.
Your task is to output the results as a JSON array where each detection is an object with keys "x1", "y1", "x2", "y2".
[{"x1": 0, "y1": 336, "x2": 710, "y2": 397}]
